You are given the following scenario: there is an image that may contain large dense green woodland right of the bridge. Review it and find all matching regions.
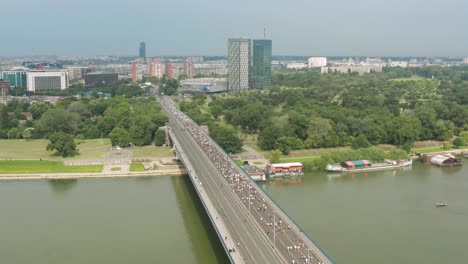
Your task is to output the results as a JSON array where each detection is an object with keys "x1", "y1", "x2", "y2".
[{"x1": 180, "y1": 67, "x2": 468, "y2": 154}]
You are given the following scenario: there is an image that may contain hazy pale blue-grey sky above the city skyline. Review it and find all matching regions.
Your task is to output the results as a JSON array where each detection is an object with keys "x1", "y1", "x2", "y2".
[{"x1": 0, "y1": 0, "x2": 468, "y2": 56}]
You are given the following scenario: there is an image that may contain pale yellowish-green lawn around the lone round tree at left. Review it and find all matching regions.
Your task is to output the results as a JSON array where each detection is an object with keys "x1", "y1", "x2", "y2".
[{"x1": 0, "y1": 139, "x2": 111, "y2": 160}]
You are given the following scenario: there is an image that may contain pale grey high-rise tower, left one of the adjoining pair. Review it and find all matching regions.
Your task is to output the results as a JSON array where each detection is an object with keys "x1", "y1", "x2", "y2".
[{"x1": 228, "y1": 38, "x2": 250, "y2": 93}]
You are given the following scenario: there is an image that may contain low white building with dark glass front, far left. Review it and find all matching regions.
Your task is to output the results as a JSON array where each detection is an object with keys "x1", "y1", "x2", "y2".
[{"x1": 26, "y1": 71, "x2": 68, "y2": 92}]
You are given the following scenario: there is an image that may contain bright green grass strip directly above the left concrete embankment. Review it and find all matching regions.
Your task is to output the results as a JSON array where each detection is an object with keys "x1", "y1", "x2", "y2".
[{"x1": 0, "y1": 160, "x2": 102, "y2": 174}]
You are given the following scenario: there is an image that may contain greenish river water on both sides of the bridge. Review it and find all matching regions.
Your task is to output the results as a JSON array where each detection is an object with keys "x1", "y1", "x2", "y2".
[{"x1": 0, "y1": 162, "x2": 468, "y2": 264}]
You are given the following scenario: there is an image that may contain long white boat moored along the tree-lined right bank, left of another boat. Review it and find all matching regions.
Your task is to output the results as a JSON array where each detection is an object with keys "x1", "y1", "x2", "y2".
[{"x1": 325, "y1": 159, "x2": 413, "y2": 172}]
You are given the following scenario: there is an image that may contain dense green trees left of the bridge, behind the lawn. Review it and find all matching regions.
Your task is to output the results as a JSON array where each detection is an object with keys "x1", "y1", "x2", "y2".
[{"x1": 0, "y1": 97, "x2": 167, "y2": 147}]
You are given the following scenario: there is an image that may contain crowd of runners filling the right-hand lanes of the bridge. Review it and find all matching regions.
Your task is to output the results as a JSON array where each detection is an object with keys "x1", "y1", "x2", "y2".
[{"x1": 160, "y1": 97, "x2": 322, "y2": 264}]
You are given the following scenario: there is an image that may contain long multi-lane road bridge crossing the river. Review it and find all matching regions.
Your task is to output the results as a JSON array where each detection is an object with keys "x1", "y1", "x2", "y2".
[{"x1": 157, "y1": 97, "x2": 334, "y2": 264}]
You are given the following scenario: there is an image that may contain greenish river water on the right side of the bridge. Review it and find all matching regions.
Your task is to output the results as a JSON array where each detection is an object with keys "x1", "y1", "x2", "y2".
[{"x1": 265, "y1": 162, "x2": 468, "y2": 264}]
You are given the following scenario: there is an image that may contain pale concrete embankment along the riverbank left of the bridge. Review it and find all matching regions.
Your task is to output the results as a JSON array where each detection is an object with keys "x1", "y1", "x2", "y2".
[{"x1": 0, "y1": 169, "x2": 186, "y2": 180}]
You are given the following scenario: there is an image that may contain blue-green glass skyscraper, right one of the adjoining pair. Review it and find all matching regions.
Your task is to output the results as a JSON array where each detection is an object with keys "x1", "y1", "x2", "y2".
[{"x1": 252, "y1": 39, "x2": 271, "y2": 89}]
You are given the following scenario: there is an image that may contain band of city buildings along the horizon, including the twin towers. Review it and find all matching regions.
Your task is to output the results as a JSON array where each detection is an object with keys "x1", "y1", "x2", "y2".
[{"x1": 0, "y1": 38, "x2": 468, "y2": 100}]
